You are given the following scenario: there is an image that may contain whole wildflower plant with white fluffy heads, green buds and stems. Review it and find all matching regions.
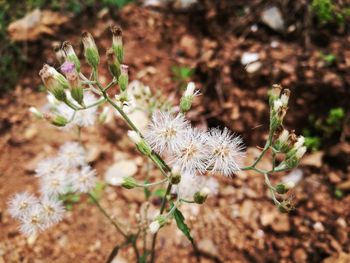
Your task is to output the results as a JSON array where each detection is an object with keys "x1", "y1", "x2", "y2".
[{"x1": 9, "y1": 26, "x2": 306, "y2": 262}]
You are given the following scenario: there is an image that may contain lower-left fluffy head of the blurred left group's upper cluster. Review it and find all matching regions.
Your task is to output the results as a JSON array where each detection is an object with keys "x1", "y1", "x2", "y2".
[{"x1": 40, "y1": 171, "x2": 69, "y2": 197}]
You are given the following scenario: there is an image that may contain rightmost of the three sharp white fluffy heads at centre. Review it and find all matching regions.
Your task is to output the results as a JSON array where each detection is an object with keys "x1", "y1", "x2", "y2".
[{"x1": 207, "y1": 128, "x2": 244, "y2": 176}]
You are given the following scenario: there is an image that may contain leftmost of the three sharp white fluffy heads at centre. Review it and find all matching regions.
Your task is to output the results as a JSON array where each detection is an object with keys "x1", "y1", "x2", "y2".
[{"x1": 146, "y1": 111, "x2": 190, "y2": 154}]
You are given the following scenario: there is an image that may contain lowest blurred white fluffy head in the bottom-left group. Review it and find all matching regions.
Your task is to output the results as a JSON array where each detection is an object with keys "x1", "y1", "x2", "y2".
[{"x1": 20, "y1": 204, "x2": 46, "y2": 236}]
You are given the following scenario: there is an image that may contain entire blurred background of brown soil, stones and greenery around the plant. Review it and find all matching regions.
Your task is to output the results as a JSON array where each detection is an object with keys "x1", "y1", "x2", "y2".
[{"x1": 0, "y1": 0, "x2": 350, "y2": 263}]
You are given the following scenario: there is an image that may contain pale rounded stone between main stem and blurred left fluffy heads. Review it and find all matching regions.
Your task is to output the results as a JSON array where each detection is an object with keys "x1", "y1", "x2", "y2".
[{"x1": 105, "y1": 160, "x2": 137, "y2": 185}]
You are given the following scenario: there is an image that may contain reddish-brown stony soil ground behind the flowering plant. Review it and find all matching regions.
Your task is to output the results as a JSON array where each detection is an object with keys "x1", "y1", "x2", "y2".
[{"x1": 0, "y1": 1, "x2": 350, "y2": 262}]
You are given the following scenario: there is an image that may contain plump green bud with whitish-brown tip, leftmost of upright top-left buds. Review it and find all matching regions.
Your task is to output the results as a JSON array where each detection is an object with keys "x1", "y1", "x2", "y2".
[{"x1": 39, "y1": 64, "x2": 69, "y2": 101}]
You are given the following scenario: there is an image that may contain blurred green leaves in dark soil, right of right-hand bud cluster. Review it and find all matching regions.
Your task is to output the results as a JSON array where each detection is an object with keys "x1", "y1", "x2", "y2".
[{"x1": 303, "y1": 107, "x2": 345, "y2": 151}]
